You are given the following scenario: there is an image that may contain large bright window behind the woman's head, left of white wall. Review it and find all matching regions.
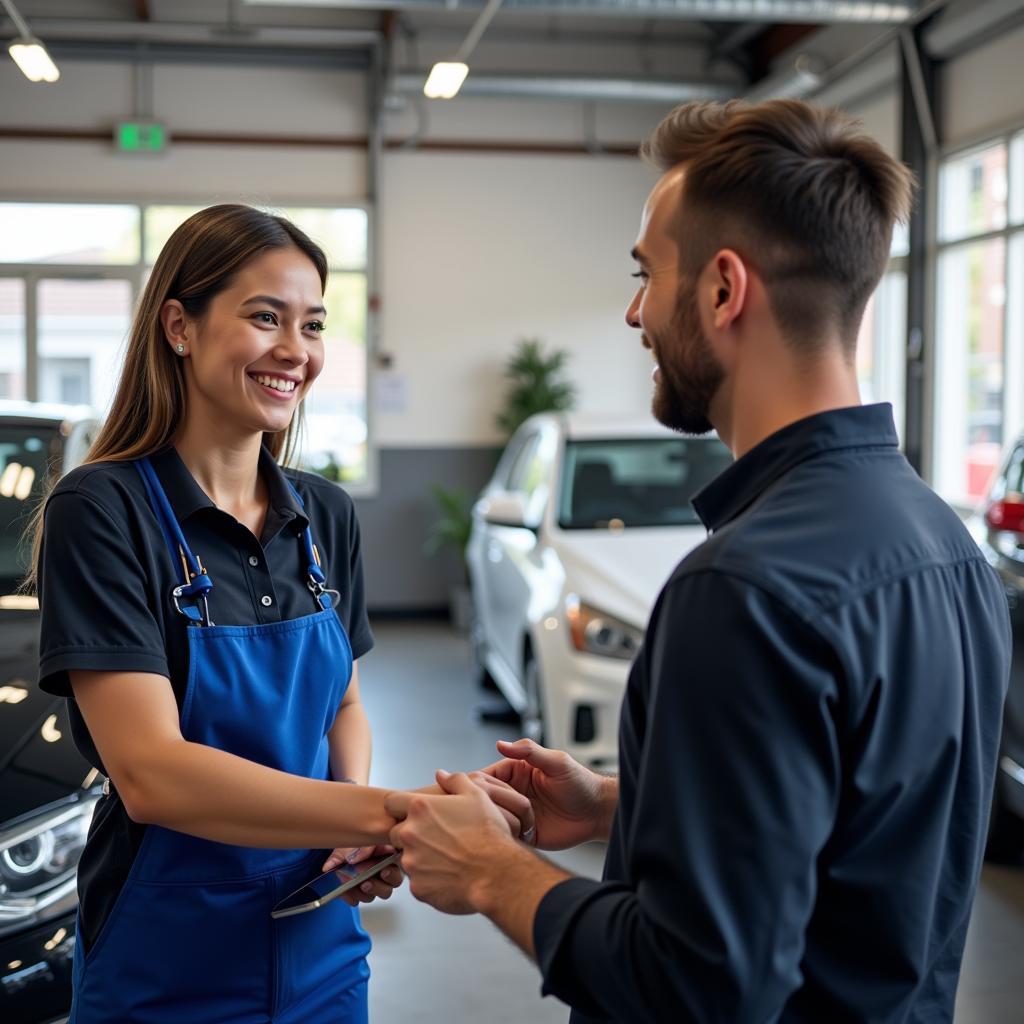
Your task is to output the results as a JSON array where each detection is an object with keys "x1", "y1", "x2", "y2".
[{"x1": 0, "y1": 203, "x2": 368, "y2": 485}]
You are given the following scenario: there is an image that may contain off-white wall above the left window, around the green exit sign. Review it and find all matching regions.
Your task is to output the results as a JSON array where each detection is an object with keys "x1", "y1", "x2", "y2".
[{"x1": 0, "y1": 59, "x2": 366, "y2": 202}]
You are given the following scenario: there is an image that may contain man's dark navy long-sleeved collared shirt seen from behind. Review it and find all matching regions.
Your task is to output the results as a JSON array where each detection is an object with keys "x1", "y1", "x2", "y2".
[{"x1": 535, "y1": 406, "x2": 1011, "y2": 1024}]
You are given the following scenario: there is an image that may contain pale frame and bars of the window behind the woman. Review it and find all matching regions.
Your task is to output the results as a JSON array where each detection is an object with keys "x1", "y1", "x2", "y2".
[{"x1": 0, "y1": 191, "x2": 380, "y2": 498}]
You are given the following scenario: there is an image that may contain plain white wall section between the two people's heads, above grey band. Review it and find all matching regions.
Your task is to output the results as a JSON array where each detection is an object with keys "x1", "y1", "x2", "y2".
[{"x1": 377, "y1": 153, "x2": 653, "y2": 446}]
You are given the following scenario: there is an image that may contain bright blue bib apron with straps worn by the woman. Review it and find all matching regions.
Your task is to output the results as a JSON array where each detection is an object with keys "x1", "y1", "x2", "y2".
[{"x1": 71, "y1": 459, "x2": 370, "y2": 1024}]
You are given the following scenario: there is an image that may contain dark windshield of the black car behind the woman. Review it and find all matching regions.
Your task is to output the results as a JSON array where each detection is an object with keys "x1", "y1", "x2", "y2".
[{"x1": 0, "y1": 424, "x2": 60, "y2": 594}]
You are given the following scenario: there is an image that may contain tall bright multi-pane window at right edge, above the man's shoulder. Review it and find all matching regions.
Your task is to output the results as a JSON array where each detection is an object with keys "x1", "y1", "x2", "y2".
[{"x1": 933, "y1": 133, "x2": 1024, "y2": 507}]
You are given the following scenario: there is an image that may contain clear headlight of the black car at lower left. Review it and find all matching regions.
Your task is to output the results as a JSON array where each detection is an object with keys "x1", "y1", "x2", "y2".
[{"x1": 0, "y1": 791, "x2": 99, "y2": 934}]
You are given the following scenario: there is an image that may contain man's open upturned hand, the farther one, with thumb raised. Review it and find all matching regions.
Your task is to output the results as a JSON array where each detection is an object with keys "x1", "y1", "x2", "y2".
[{"x1": 482, "y1": 739, "x2": 618, "y2": 850}]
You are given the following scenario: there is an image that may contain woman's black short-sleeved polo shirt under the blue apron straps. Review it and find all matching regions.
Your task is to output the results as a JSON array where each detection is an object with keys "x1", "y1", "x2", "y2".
[{"x1": 39, "y1": 447, "x2": 373, "y2": 945}]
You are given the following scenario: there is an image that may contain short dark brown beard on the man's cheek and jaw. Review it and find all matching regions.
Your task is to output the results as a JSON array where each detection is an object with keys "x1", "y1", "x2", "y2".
[{"x1": 648, "y1": 284, "x2": 725, "y2": 434}]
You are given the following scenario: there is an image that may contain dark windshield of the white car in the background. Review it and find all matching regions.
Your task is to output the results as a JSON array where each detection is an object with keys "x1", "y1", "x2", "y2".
[{"x1": 558, "y1": 437, "x2": 732, "y2": 529}]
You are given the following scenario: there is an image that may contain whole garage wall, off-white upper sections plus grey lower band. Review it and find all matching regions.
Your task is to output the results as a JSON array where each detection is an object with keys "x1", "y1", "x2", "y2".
[{"x1": 0, "y1": 19, "x2": 1024, "y2": 610}]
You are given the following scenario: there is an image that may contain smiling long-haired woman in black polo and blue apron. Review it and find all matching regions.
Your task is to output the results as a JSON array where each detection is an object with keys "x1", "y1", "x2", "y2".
[{"x1": 36, "y1": 206, "x2": 528, "y2": 1024}]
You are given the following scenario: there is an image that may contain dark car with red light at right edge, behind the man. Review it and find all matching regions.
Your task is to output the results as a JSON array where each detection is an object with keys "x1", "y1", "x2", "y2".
[{"x1": 972, "y1": 436, "x2": 1024, "y2": 863}]
